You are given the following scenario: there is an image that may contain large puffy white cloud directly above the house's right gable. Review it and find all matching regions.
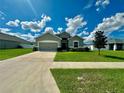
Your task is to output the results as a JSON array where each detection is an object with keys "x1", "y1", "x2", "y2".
[{"x1": 65, "y1": 15, "x2": 87, "y2": 35}]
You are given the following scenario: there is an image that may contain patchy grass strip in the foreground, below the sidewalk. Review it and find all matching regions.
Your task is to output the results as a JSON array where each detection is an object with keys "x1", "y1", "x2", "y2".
[{"x1": 51, "y1": 69, "x2": 124, "y2": 93}]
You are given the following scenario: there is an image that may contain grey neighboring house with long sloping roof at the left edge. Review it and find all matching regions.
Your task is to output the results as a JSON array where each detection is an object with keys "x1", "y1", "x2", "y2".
[{"x1": 0, "y1": 32, "x2": 32, "y2": 49}]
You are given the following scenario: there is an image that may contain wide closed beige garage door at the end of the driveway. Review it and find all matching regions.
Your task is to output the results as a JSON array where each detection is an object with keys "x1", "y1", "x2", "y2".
[{"x1": 39, "y1": 42, "x2": 58, "y2": 51}]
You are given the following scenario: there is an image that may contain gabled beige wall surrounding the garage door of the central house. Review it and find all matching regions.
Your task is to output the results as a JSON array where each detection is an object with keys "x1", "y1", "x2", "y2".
[{"x1": 36, "y1": 33, "x2": 61, "y2": 47}]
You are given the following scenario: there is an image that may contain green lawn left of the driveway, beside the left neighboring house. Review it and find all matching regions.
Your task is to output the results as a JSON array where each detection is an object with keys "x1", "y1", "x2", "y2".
[{"x1": 0, "y1": 49, "x2": 32, "y2": 60}]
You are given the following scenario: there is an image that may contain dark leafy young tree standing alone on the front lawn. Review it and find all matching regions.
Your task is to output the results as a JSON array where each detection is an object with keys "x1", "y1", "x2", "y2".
[{"x1": 93, "y1": 31, "x2": 107, "y2": 55}]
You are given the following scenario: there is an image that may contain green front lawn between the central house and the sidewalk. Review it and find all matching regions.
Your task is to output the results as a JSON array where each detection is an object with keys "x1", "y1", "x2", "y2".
[{"x1": 54, "y1": 50, "x2": 124, "y2": 62}]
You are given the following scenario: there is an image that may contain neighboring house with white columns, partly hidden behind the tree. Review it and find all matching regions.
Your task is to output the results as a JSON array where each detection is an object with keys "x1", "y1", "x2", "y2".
[{"x1": 87, "y1": 38, "x2": 124, "y2": 51}]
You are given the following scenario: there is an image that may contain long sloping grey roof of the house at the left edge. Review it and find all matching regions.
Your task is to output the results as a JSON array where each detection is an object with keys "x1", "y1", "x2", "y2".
[{"x1": 0, "y1": 32, "x2": 30, "y2": 43}]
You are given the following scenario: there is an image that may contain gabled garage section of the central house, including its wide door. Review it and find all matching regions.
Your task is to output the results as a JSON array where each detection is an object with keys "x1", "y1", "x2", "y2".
[{"x1": 36, "y1": 33, "x2": 61, "y2": 51}]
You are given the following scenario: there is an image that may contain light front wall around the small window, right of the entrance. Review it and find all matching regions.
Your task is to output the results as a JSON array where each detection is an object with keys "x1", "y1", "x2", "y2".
[{"x1": 69, "y1": 37, "x2": 83, "y2": 48}]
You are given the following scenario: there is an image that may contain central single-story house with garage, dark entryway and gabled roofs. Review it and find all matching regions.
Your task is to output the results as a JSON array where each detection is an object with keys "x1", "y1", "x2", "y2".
[{"x1": 36, "y1": 32, "x2": 83, "y2": 51}]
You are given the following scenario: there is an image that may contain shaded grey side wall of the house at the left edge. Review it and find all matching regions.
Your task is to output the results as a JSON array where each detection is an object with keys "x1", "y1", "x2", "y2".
[{"x1": 0, "y1": 40, "x2": 20, "y2": 49}]
